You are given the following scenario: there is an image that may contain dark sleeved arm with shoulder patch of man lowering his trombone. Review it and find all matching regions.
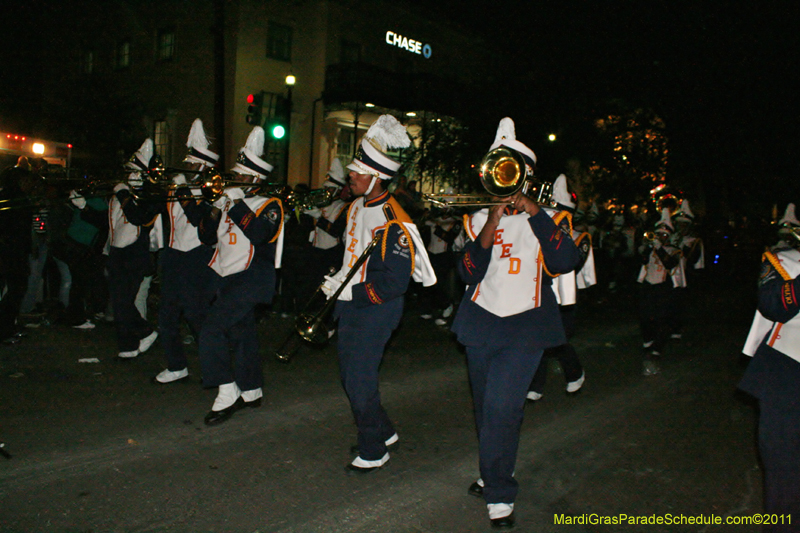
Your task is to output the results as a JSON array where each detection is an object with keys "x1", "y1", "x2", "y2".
[{"x1": 353, "y1": 224, "x2": 412, "y2": 307}]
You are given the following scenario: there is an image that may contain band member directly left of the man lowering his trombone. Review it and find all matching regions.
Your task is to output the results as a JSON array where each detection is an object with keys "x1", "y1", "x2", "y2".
[{"x1": 198, "y1": 126, "x2": 283, "y2": 425}]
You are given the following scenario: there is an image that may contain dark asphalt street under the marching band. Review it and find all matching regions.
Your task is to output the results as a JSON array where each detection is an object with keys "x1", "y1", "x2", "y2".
[{"x1": 0, "y1": 270, "x2": 768, "y2": 533}]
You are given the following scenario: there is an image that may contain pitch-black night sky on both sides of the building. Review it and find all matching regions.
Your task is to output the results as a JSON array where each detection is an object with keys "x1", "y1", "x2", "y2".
[{"x1": 0, "y1": 0, "x2": 800, "y2": 202}]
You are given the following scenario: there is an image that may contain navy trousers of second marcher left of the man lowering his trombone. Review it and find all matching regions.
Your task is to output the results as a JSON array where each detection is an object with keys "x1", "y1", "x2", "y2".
[{"x1": 158, "y1": 245, "x2": 216, "y2": 372}]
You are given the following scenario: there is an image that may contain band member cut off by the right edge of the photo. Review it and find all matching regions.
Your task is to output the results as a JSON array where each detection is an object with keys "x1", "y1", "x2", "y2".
[{"x1": 739, "y1": 204, "x2": 800, "y2": 532}]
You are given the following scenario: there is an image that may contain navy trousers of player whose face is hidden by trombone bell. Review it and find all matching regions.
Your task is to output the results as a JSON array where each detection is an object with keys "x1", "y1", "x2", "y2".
[{"x1": 467, "y1": 339, "x2": 542, "y2": 503}]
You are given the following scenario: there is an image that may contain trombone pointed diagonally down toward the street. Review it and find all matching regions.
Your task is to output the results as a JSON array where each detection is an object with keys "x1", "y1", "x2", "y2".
[{"x1": 275, "y1": 233, "x2": 383, "y2": 363}]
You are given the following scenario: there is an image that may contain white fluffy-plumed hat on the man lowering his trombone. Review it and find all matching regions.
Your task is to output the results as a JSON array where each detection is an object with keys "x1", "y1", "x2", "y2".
[{"x1": 347, "y1": 115, "x2": 411, "y2": 180}]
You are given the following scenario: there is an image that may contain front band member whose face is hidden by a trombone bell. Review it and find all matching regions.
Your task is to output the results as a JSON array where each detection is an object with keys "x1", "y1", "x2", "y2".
[{"x1": 452, "y1": 118, "x2": 578, "y2": 528}]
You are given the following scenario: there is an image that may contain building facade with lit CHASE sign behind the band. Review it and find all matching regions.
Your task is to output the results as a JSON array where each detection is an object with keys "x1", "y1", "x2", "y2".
[{"x1": 47, "y1": 0, "x2": 493, "y2": 188}]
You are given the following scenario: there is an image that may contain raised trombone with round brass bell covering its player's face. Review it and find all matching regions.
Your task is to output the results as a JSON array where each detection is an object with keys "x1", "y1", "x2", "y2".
[{"x1": 422, "y1": 146, "x2": 552, "y2": 207}]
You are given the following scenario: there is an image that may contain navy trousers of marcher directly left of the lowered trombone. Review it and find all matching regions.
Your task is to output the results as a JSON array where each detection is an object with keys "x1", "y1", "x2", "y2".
[{"x1": 198, "y1": 270, "x2": 265, "y2": 391}]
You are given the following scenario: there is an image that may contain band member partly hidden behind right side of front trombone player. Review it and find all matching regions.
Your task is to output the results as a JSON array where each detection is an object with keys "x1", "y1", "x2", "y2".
[{"x1": 527, "y1": 174, "x2": 597, "y2": 401}]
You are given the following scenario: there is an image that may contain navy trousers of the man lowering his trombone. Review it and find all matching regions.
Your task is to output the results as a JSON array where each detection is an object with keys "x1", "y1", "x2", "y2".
[{"x1": 336, "y1": 298, "x2": 403, "y2": 461}]
